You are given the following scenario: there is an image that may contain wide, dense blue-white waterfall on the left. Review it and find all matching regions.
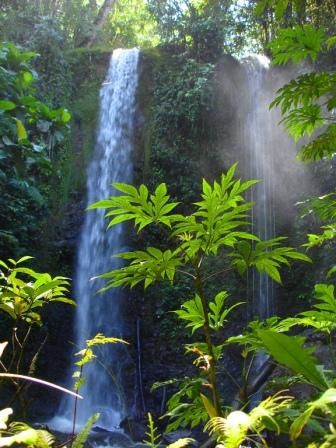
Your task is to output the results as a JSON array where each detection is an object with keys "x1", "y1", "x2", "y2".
[{"x1": 50, "y1": 49, "x2": 139, "y2": 430}]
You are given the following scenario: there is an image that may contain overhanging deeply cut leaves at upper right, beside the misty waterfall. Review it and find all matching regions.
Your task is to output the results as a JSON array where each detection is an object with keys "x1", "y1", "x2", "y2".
[{"x1": 270, "y1": 25, "x2": 336, "y2": 161}]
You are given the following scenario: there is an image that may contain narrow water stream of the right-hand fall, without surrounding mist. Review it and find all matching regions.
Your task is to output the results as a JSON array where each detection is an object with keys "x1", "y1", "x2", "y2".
[{"x1": 243, "y1": 55, "x2": 278, "y2": 319}]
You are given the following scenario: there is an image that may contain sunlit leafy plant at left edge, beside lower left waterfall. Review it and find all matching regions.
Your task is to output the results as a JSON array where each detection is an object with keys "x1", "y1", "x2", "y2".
[{"x1": 0, "y1": 256, "x2": 75, "y2": 413}]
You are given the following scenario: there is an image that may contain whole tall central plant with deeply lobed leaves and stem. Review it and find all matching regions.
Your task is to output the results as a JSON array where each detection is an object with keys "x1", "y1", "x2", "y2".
[{"x1": 89, "y1": 166, "x2": 309, "y2": 438}]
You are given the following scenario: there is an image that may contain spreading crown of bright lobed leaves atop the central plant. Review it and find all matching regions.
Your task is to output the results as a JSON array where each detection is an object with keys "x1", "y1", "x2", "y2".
[{"x1": 89, "y1": 165, "x2": 309, "y2": 289}]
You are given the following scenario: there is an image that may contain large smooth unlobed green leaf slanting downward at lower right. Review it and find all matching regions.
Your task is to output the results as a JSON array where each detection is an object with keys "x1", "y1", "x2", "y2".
[{"x1": 258, "y1": 330, "x2": 328, "y2": 390}]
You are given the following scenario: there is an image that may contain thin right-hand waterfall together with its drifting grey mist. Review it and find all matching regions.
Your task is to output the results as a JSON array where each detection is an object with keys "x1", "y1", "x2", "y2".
[{"x1": 212, "y1": 55, "x2": 300, "y2": 321}]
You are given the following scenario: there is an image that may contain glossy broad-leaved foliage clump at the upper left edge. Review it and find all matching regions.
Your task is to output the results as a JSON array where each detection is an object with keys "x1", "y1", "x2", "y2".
[{"x1": 0, "y1": 43, "x2": 71, "y2": 176}]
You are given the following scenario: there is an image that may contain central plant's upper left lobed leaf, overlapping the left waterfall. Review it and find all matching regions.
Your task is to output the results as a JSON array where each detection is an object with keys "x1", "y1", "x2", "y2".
[{"x1": 88, "y1": 183, "x2": 178, "y2": 231}]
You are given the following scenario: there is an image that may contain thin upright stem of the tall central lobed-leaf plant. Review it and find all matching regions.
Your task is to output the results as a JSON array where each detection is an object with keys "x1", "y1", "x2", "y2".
[{"x1": 195, "y1": 266, "x2": 222, "y2": 417}]
